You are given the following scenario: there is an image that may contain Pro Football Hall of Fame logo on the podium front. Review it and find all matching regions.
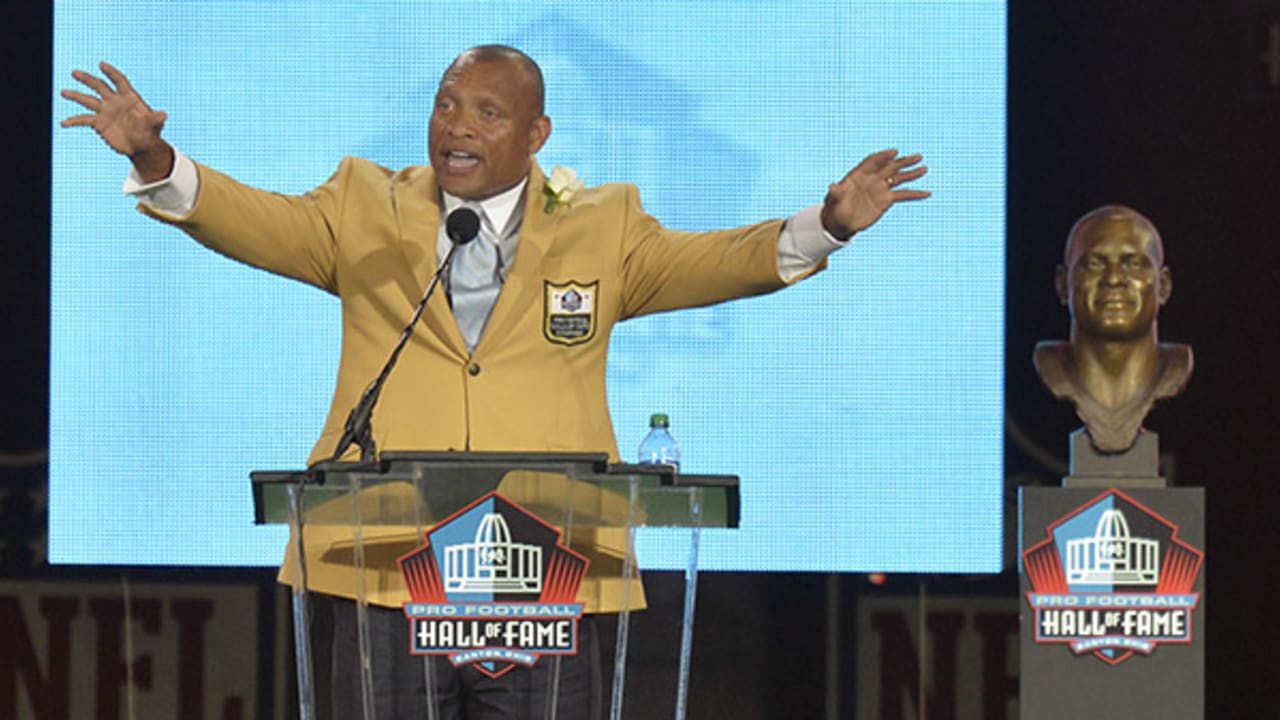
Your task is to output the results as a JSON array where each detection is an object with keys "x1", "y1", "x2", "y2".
[{"x1": 398, "y1": 492, "x2": 589, "y2": 678}]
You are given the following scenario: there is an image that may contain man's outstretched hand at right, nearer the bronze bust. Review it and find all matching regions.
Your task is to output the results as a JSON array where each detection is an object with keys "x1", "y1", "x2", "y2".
[{"x1": 822, "y1": 150, "x2": 929, "y2": 240}]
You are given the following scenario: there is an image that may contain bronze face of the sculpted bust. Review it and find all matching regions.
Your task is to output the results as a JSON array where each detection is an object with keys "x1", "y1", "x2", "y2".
[{"x1": 1059, "y1": 217, "x2": 1172, "y2": 341}]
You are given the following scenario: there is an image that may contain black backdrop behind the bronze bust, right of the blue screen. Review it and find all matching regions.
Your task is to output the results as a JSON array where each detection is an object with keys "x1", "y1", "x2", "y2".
[{"x1": 1006, "y1": 0, "x2": 1280, "y2": 717}]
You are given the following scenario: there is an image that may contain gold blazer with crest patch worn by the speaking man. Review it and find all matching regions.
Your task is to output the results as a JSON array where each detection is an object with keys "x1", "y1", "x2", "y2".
[{"x1": 140, "y1": 158, "x2": 820, "y2": 611}]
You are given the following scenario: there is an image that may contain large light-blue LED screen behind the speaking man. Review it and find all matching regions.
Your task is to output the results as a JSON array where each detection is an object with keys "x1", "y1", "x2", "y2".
[{"x1": 50, "y1": 0, "x2": 1006, "y2": 573}]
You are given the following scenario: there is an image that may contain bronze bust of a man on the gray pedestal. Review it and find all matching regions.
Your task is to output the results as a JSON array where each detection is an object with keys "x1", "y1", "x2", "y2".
[{"x1": 1034, "y1": 205, "x2": 1192, "y2": 454}]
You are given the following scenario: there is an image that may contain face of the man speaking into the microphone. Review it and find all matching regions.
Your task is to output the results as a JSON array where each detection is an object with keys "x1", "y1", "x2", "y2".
[{"x1": 428, "y1": 55, "x2": 550, "y2": 200}]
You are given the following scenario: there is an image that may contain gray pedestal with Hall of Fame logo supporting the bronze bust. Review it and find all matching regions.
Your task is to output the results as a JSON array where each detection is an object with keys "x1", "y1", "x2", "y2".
[{"x1": 1019, "y1": 433, "x2": 1204, "y2": 720}]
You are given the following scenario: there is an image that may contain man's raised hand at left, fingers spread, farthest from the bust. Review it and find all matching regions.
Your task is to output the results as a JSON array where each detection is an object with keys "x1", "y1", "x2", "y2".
[{"x1": 61, "y1": 63, "x2": 173, "y2": 182}]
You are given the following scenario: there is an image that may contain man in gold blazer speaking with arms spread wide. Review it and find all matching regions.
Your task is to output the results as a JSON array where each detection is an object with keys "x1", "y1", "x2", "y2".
[{"x1": 63, "y1": 45, "x2": 928, "y2": 719}]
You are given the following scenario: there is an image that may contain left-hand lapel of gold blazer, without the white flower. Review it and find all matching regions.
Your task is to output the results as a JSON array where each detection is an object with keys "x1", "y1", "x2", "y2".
[{"x1": 393, "y1": 165, "x2": 471, "y2": 359}]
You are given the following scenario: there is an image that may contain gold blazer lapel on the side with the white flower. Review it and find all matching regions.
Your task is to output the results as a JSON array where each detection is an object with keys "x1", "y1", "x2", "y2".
[{"x1": 476, "y1": 160, "x2": 564, "y2": 355}]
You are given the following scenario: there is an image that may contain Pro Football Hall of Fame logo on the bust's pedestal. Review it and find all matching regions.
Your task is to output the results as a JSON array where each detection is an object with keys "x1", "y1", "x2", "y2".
[{"x1": 1023, "y1": 489, "x2": 1204, "y2": 665}]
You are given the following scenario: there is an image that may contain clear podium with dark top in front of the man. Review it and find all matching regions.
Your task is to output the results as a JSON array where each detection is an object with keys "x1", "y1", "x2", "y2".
[{"x1": 252, "y1": 452, "x2": 739, "y2": 720}]
